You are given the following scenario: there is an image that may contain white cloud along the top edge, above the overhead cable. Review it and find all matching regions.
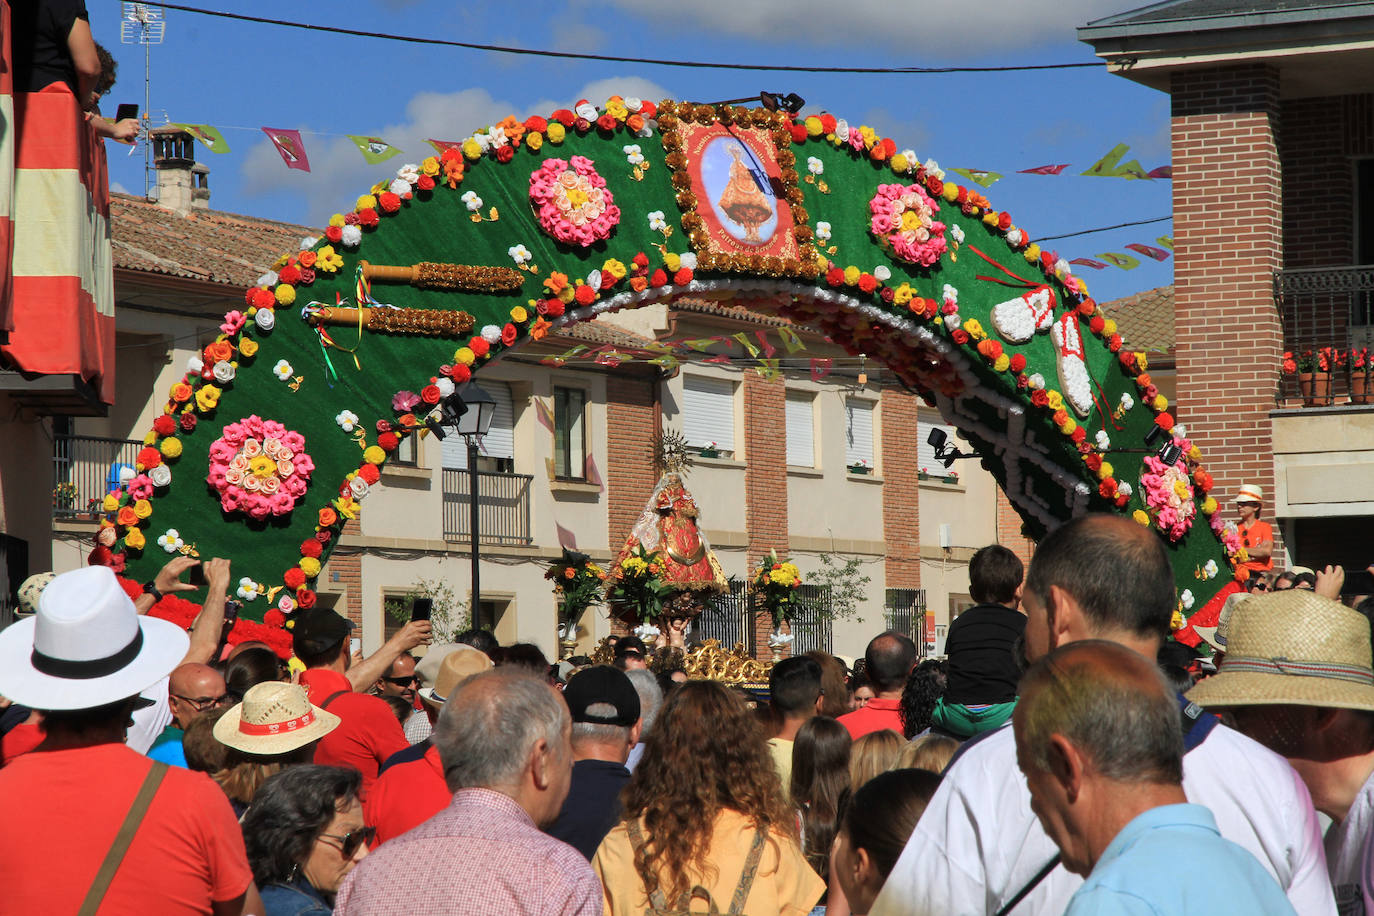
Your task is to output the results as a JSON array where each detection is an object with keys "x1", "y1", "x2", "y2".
[{"x1": 605, "y1": 0, "x2": 1123, "y2": 54}]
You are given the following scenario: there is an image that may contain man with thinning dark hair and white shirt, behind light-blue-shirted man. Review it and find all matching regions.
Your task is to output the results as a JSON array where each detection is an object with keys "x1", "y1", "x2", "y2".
[{"x1": 870, "y1": 515, "x2": 1336, "y2": 916}]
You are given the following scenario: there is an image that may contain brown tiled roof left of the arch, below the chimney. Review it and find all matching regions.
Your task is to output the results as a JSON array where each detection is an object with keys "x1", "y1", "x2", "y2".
[{"x1": 110, "y1": 194, "x2": 320, "y2": 287}]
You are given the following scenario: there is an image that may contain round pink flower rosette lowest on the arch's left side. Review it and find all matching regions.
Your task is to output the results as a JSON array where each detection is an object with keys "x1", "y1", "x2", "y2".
[{"x1": 205, "y1": 415, "x2": 315, "y2": 520}]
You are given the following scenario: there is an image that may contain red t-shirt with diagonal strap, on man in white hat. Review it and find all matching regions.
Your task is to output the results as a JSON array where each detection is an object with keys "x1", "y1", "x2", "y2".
[{"x1": 0, "y1": 744, "x2": 253, "y2": 916}]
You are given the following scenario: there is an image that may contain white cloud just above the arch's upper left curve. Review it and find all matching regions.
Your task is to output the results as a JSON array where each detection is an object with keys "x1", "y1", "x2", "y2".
[{"x1": 242, "y1": 77, "x2": 671, "y2": 225}]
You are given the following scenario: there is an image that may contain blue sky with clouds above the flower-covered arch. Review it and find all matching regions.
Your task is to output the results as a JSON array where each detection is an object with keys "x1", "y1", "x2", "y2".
[{"x1": 87, "y1": 0, "x2": 1173, "y2": 301}]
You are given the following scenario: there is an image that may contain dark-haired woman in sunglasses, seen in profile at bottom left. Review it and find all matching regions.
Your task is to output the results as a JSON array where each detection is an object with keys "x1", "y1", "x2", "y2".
[{"x1": 243, "y1": 764, "x2": 376, "y2": 916}]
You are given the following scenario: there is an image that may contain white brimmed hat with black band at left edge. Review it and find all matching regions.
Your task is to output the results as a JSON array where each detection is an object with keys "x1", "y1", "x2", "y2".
[{"x1": 0, "y1": 566, "x2": 191, "y2": 710}]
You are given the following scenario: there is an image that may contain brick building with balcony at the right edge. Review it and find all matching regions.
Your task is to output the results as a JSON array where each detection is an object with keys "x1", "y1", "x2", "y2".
[{"x1": 1079, "y1": 0, "x2": 1374, "y2": 569}]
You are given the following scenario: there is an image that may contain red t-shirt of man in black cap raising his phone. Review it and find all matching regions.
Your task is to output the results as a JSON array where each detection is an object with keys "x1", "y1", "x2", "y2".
[{"x1": 301, "y1": 667, "x2": 409, "y2": 798}]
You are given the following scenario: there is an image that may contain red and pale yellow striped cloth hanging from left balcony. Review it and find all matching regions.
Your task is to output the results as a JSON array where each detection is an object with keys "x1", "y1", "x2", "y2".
[{"x1": 0, "y1": 0, "x2": 114, "y2": 404}]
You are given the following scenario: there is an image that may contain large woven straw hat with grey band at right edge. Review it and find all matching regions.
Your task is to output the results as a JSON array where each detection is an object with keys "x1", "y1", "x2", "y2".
[{"x1": 1187, "y1": 589, "x2": 1374, "y2": 710}]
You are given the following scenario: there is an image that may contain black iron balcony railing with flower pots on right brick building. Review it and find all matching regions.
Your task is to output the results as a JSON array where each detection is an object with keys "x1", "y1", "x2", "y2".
[{"x1": 1274, "y1": 264, "x2": 1374, "y2": 402}]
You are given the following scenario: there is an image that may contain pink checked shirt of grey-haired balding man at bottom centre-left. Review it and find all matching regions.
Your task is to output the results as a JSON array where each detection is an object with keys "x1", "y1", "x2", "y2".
[{"x1": 334, "y1": 788, "x2": 602, "y2": 916}]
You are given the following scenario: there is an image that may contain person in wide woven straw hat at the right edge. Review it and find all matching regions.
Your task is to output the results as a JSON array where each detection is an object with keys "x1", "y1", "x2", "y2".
[{"x1": 1189, "y1": 589, "x2": 1374, "y2": 916}]
